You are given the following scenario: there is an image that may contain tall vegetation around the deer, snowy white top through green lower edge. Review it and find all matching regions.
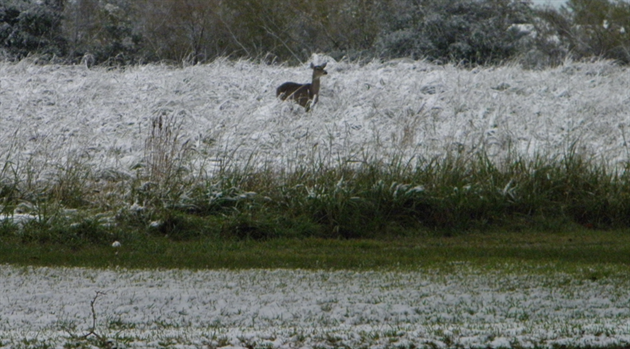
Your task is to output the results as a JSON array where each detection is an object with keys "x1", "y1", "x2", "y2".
[{"x1": 0, "y1": 57, "x2": 630, "y2": 239}]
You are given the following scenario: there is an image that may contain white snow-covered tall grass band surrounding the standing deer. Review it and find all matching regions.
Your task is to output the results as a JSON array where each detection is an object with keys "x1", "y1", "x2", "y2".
[{"x1": 0, "y1": 57, "x2": 630, "y2": 179}]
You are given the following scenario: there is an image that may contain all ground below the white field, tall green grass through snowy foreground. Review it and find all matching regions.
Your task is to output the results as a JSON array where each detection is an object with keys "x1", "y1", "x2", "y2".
[{"x1": 0, "y1": 158, "x2": 630, "y2": 349}]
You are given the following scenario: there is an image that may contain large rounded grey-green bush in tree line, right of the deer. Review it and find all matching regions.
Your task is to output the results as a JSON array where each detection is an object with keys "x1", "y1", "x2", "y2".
[{"x1": 377, "y1": 0, "x2": 532, "y2": 64}]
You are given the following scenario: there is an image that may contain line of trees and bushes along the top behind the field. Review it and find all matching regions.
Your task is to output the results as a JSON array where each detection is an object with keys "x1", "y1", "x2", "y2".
[{"x1": 0, "y1": 0, "x2": 630, "y2": 68}]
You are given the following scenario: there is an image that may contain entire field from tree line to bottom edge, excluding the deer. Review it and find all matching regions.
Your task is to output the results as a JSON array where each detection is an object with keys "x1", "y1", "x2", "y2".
[{"x1": 0, "y1": 57, "x2": 630, "y2": 348}]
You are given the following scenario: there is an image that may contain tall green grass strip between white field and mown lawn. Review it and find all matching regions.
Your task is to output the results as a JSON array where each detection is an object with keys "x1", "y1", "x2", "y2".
[{"x1": 0, "y1": 144, "x2": 630, "y2": 247}]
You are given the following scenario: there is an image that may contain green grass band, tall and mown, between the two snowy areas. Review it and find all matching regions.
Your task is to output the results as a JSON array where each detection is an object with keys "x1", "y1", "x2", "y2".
[{"x1": 0, "y1": 140, "x2": 630, "y2": 270}]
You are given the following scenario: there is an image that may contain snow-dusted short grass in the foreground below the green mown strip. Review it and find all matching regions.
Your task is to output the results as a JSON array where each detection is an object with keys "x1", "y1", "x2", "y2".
[{"x1": 0, "y1": 264, "x2": 630, "y2": 348}]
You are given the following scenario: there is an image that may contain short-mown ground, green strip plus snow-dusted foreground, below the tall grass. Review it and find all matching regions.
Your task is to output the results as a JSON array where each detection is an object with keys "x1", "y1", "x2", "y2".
[{"x1": 0, "y1": 227, "x2": 630, "y2": 349}]
